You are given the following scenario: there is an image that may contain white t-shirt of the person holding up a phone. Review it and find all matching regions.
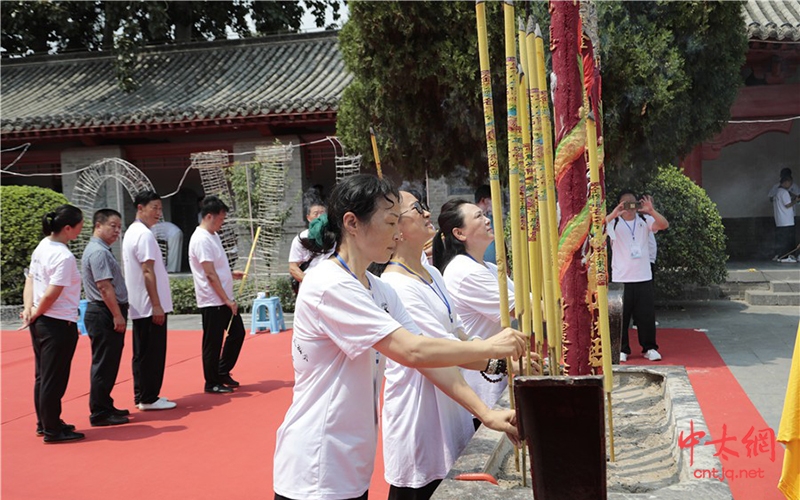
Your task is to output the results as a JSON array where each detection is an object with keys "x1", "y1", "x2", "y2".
[{"x1": 606, "y1": 214, "x2": 656, "y2": 283}]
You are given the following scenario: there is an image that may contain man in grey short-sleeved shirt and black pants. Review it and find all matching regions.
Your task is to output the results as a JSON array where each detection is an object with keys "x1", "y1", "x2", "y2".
[{"x1": 81, "y1": 208, "x2": 130, "y2": 427}]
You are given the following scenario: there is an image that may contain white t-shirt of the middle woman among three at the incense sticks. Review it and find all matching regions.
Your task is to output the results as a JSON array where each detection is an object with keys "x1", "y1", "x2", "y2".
[{"x1": 381, "y1": 264, "x2": 475, "y2": 488}]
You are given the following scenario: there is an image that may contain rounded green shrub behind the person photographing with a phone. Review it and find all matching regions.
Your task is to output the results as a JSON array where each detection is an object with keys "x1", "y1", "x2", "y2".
[{"x1": 607, "y1": 165, "x2": 728, "y2": 298}]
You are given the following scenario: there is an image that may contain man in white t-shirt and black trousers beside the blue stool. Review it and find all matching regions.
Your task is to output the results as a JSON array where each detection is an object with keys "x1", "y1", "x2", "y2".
[{"x1": 189, "y1": 196, "x2": 244, "y2": 394}]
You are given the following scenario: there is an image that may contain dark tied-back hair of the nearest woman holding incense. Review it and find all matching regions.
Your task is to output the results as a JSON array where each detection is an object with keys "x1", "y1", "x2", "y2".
[{"x1": 300, "y1": 174, "x2": 400, "y2": 254}]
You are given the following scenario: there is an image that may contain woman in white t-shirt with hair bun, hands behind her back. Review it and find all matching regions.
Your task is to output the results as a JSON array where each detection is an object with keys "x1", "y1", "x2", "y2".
[{"x1": 20, "y1": 205, "x2": 84, "y2": 443}]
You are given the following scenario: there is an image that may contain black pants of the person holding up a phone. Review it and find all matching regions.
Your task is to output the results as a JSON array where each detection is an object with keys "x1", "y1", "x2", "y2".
[{"x1": 620, "y1": 280, "x2": 658, "y2": 354}]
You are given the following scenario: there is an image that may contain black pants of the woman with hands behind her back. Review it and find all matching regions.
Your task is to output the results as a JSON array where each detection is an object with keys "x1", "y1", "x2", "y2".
[{"x1": 30, "y1": 316, "x2": 78, "y2": 436}]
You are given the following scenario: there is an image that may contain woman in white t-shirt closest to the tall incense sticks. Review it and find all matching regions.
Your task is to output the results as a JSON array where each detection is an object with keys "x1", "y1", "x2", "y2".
[{"x1": 433, "y1": 200, "x2": 514, "y2": 422}]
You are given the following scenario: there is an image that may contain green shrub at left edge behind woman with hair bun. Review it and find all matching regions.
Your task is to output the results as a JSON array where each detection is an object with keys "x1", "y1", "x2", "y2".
[{"x1": 0, "y1": 186, "x2": 68, "y2": 304}]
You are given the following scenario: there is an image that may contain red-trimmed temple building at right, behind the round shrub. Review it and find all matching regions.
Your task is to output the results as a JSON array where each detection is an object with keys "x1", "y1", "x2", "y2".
[{"x1": 682, "y1": 0, "x2": 800, "y2": 260}]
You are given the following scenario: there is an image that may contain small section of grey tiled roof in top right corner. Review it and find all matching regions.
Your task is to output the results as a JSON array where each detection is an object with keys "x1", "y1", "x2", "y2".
[{"x1": 744, "y1": 0, "x2": 800, "y2": 42}]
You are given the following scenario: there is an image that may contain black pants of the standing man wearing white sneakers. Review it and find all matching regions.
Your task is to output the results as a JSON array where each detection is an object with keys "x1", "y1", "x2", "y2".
[{"x1": 133, "y1": 315, "x2": 169, "y2": 404}]
